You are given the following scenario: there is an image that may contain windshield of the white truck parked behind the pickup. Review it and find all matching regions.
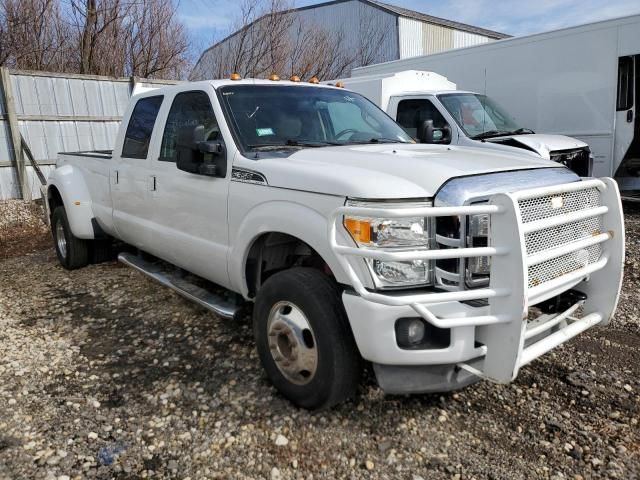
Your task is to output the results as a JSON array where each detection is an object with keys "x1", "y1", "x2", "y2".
[{"x1": 438, "y1": 93, "x2": 530, "y2": 138}]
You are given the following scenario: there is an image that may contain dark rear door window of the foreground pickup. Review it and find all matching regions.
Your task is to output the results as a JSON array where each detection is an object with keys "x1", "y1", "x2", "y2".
[{"x1": 122, "y1": 95, "x2": 163, "y2": 158}]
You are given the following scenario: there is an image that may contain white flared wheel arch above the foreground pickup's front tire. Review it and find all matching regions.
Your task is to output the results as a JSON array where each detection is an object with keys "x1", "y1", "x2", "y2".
[{"x1": 228, "y1": 200, "x2": 369, "y2": 297}]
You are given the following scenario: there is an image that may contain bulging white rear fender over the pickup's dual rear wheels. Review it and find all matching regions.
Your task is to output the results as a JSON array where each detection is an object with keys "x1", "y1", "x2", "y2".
[{"x1": 47, "y1": 164, "x2": 95, "y2": 239}]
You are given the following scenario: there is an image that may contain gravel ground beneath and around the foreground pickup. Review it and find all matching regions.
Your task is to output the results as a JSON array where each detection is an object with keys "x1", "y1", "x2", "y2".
[{"x1": 0, "y1": 202, "x2": 640, "y2": 480}]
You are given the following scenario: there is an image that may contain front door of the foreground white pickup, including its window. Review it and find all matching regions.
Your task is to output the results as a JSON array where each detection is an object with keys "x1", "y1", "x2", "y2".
[{"x1": 148, "y1": 90, "x2": 231, "y2": 286}]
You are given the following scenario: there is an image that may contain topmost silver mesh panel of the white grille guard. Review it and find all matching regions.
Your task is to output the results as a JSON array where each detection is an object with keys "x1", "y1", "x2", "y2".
[{"x1": 518, "y1": 188, "x2": 600, "y2": 223}]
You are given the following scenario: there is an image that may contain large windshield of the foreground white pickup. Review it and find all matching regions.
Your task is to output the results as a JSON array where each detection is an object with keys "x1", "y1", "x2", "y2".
[{"x1": 220, "y1": 85, "x2": 413, "y2": 151}]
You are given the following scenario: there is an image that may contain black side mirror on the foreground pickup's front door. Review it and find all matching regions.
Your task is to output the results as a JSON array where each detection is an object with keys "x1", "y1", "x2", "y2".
[{"x1": 176, "y1": 125, "x2": 227, "y2": 177}]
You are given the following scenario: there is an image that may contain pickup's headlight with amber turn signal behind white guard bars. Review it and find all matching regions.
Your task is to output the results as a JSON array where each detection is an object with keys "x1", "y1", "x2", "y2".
[{"x1": 343, "y1": 200, "x2": 433, "y2": 288}]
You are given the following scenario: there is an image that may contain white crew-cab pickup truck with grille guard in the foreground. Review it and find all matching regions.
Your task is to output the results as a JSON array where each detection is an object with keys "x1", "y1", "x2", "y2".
[{"x1": 46, "y1": 79, "x2": 624, "y2": 408}]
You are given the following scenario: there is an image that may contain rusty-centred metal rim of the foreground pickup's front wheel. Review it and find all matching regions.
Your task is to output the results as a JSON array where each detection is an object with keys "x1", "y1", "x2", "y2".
[{"x1": 267, "y1": 302, "x2": 318, "y2": 385}]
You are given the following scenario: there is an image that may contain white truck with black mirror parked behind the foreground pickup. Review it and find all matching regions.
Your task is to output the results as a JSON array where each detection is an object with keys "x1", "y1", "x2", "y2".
[{"x1": 339, "y1": 70, "x2": 592, "y2": 177}]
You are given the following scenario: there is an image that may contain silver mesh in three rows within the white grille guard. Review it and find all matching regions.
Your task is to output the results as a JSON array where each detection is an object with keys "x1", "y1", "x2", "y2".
[{"x1": 518, "y1": 188, "x2": 602, "y2": 288}]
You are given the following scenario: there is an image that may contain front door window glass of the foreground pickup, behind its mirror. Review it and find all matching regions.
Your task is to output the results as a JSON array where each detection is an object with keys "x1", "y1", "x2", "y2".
[{"x1": 158, "y1": 91, "x2": 220, "y2": 162}]
